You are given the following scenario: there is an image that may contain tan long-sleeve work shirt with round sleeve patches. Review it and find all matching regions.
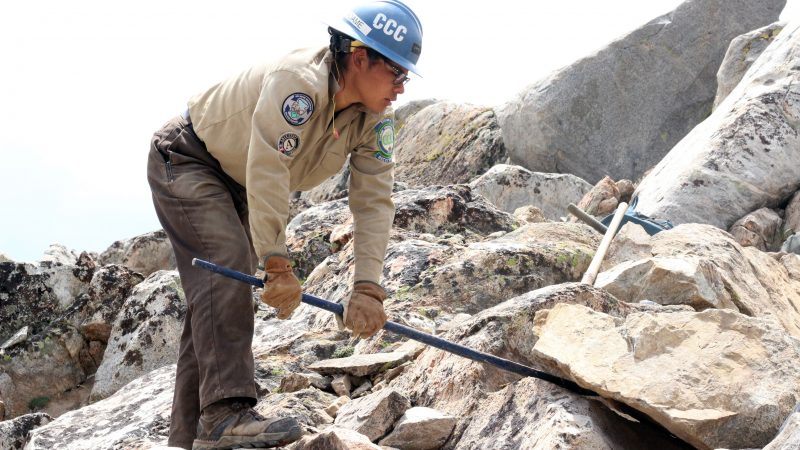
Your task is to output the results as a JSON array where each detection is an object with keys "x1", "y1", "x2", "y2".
[{"x1": 189, "y1": 49, "x2": 394, "y2": 283}]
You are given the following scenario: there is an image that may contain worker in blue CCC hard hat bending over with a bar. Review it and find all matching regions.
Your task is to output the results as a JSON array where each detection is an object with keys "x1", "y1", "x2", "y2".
[{"x1": 147, "y1": 0, "x2": 422, "y2": 449}]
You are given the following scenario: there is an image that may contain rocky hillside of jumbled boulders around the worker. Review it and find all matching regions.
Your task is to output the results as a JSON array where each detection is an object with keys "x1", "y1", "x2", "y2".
[{"x1": 0, "y1": 0, "x2": 800, "y2": 450}]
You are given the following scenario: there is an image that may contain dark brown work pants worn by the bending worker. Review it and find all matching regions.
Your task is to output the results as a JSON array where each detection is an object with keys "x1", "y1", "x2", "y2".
[{"x1": 147, "y1": 117, "x2": 256, "y2": 448}]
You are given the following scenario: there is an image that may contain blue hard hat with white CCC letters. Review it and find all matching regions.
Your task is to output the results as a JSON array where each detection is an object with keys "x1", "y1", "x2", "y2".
[{"x1": 326, "y1": 0, "x2": 422, "y2": 75}]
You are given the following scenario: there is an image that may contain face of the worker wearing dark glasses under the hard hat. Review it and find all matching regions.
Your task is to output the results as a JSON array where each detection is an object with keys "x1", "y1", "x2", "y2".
[{"x1": 355, "y1": 50, "x2": 408, "y2": 114}]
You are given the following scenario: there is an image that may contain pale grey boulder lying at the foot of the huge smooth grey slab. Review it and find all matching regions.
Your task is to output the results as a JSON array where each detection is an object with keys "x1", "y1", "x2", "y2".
[{"x1": 469, "y1": 164, "x2": 592, "y2": 220}]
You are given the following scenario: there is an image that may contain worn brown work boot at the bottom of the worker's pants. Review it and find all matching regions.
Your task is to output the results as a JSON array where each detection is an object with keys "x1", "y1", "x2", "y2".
[{"x1": 192, "y1": 399, "x2": 303, "y2": 450}]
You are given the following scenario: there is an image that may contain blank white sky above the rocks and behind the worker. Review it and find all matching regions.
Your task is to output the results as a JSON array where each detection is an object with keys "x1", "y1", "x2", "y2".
[{"x1": 0, "y1": 0, "x2": 800, "y2": 261}]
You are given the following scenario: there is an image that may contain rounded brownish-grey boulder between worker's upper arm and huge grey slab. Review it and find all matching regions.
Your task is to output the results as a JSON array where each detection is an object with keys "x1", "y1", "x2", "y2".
[{"x1": 395, "y1": 102, "x2": 507, "y2": 187}]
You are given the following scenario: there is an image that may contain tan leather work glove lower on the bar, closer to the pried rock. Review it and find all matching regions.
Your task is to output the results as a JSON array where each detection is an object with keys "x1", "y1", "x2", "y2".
[{"x1": 336, "y1": 281, "x2": 386, "y2": 339}]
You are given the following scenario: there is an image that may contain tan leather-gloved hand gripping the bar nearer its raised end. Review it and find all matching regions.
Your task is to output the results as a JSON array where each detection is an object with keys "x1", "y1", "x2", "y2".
[{"x1": 261, "y1": 255, "x2": 303, "y2": 320}]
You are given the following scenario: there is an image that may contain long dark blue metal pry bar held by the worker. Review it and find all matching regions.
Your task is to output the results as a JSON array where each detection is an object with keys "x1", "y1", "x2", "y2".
[{"x1": 192, "y1": 258, "x2": 597, "y2": 396}]
